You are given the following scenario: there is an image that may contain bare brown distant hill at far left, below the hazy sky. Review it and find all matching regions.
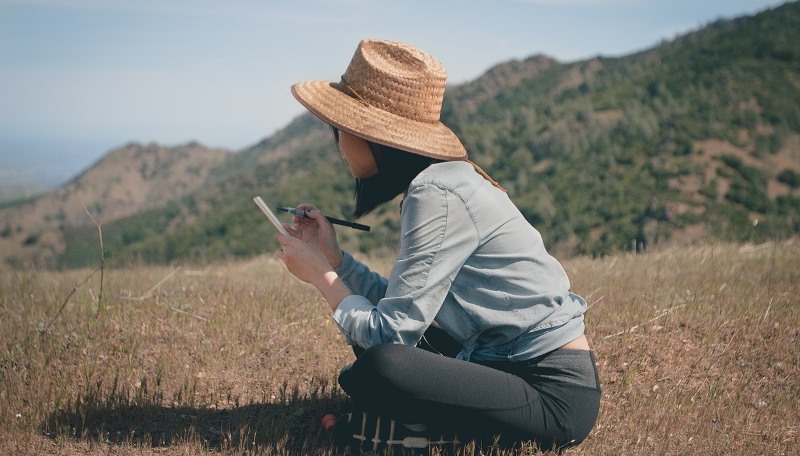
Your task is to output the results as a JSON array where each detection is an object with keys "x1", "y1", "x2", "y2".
[{"x1": 0, "y1": 143, "x2": 230, "y2": 264}]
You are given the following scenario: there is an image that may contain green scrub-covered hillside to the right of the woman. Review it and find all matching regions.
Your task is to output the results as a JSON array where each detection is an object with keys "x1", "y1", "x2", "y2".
[{"x1": 448, "y1": 3, "x2": 800, "y2": 254}]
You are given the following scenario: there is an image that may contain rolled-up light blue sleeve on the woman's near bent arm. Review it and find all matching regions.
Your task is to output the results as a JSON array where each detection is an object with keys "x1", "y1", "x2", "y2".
[{"x1": 333, "y1": 184, "x2": 478, "y2": 348}]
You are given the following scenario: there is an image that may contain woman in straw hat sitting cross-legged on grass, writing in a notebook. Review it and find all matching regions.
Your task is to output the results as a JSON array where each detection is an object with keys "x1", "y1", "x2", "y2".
[{"x1": 277, "y1": 40, "x2": 600, "y2": 450}]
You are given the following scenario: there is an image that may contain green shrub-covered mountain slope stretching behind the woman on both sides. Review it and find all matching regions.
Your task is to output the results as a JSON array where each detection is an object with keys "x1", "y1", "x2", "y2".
[{"x1": 0, "y1": 2, "x2": 800, "y2": 266}]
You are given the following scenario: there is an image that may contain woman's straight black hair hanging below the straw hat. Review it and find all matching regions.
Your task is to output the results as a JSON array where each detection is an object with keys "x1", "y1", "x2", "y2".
[{"x1": 332, "y1": 127, "x2": 441, "y2": 218}]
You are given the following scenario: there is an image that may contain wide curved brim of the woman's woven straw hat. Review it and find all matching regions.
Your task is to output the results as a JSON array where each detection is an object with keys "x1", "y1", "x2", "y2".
[{"x1": 292, "y1": 81, "x2": 467, "y2": 160}]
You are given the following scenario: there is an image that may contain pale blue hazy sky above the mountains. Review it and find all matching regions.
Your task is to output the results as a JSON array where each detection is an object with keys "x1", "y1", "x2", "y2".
[{"x1": 0, "y1": 0, "x2": 784, "y2": 182}]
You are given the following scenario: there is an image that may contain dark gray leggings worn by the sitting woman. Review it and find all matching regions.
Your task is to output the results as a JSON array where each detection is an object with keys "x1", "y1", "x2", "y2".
[{"x1": 339, "y1": 344, "x2": 600, "y2": 449}]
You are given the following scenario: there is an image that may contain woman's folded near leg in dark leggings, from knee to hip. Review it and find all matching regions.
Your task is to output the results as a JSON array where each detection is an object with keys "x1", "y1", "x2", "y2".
[{"x1": 339, "y1": 344, "x2": 599, "y2": 447}]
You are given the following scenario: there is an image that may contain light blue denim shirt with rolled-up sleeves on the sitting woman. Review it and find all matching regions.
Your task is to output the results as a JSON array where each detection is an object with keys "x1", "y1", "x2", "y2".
[{"x1": 333, "y1": 161, "x2": 586, "y2": 361}]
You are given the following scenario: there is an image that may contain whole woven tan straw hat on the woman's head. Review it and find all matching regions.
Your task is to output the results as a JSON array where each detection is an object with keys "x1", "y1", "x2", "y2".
[{"x1": 292, "y1": 40, "x2": 467, "y2": 160}]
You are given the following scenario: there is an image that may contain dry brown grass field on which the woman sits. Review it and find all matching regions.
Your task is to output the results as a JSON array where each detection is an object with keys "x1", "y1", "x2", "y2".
[{"x1": 0, "y1": 241, "x2": 800, "y2": 455}]
